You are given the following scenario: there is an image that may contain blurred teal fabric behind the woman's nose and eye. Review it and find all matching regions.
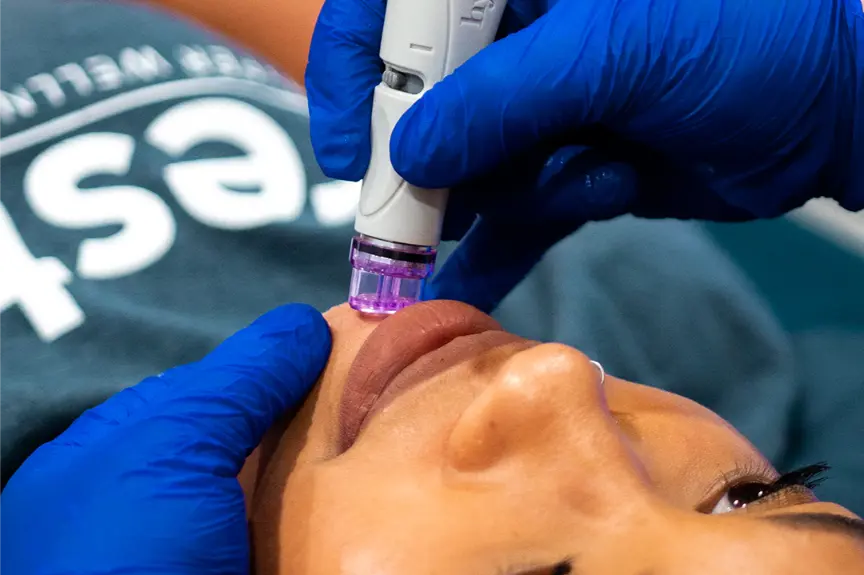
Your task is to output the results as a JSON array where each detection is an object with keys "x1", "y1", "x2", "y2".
[{"x1": 498, "y1": 218, "x2": 864, "y2": 514}]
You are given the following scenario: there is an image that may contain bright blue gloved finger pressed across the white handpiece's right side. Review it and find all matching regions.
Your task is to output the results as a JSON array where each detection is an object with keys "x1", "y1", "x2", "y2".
[{"x1": 390, "y1": 2, "x2": 615, "y2": 188}]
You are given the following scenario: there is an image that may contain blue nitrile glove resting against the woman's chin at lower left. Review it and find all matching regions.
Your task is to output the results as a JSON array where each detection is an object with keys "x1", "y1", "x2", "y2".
[{"x1": 0, "y1": 304, "x2": 330, "y2": 575}]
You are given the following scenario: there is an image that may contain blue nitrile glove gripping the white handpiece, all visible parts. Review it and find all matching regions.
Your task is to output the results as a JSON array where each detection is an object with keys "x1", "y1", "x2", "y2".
[{"x1": 306, "y1": 0, "x2": 864, "y2": 310}]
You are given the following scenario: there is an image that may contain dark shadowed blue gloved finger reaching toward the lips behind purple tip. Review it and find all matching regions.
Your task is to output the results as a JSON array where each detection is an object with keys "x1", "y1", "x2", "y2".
[{"x1": 424, "y1": 147, "x2": 639, "y2": 313}]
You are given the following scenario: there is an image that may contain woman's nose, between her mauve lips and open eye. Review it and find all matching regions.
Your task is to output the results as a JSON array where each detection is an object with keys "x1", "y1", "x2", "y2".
[{"x1": 446, "y1": 344, "x2": 647, "y2": 503}]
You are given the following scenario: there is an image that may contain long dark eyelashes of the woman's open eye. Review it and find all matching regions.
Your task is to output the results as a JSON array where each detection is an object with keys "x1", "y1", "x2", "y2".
[{"x1": 698, "y1": 461, "x2": 831, "y2": 513}]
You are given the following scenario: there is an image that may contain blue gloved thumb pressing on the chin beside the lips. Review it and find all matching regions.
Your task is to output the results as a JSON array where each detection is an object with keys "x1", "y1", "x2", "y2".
[{"x1": 52, "y1": 304, "x2": 331, "y2": 476}]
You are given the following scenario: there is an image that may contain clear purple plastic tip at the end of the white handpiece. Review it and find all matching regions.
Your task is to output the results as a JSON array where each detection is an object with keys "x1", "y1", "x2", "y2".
[{"x1": 348, "y1": 235, "x2": 437, "y2": 315}]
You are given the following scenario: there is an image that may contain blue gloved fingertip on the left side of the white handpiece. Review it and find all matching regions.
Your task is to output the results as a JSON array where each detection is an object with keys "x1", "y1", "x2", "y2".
[{"x1": 306, "y1": 0, "x2": 385, "y2": 181}]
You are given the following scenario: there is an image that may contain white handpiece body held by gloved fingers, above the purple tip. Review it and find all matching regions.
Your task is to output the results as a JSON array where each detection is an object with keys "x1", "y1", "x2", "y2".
[{"x1": 354, "y1": 0, "x2": 506, "y2": 246}]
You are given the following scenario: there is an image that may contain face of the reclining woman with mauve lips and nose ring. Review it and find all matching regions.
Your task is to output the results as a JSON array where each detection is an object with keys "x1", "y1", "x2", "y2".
[{"x1": 241, "y1": 302, "x2": 864, "y2": 575}]
